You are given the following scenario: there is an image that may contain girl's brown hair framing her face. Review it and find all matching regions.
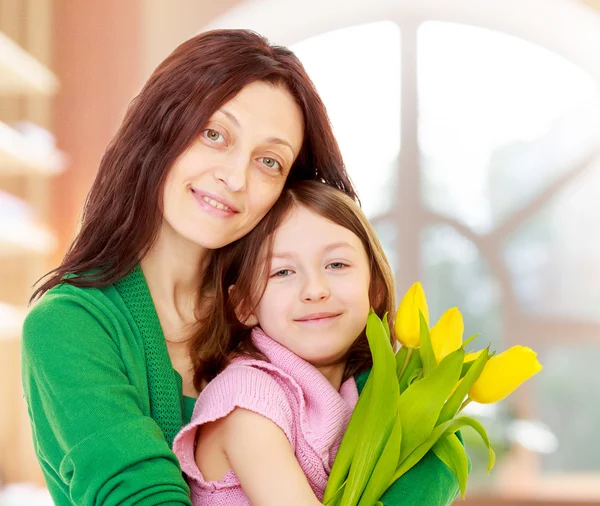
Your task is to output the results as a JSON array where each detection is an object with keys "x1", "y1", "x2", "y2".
[{"x1": 191, "y1": 181, "x2": 395, "y2": 389}]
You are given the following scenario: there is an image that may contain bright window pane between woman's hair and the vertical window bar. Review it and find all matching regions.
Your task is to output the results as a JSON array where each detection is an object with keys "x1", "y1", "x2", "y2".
[{"x1": 292, "y1": 21, "x2": 400, "y2": 216}]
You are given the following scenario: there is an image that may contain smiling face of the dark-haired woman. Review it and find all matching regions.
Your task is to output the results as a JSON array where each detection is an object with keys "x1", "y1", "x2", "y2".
[{"x1": 161, "y1": 81, "x2": 304, "y2": 249}]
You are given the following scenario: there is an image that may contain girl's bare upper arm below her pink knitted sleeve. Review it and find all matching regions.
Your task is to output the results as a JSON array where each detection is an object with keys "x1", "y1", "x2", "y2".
[{"x1": 218, "y1": 408, "x2": 321, "y2": 506}]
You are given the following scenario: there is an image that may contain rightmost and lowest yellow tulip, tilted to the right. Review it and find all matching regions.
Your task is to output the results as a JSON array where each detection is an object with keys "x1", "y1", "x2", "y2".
[{"x1": 469, "y1": 346, "x2": 542, "y2": 404}]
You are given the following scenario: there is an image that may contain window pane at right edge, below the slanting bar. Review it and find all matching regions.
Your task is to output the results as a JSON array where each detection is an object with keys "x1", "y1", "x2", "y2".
[{"x1": 504, "y1": 160, "x2": 600, "y2": 320}]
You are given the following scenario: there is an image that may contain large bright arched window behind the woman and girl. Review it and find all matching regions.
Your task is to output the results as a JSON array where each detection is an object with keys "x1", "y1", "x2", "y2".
[{"x1": 213, "y1": 0, "x2": 600, "y2": 497}]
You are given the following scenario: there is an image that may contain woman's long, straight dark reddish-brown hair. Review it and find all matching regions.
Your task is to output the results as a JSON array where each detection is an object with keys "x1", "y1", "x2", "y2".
[{"x1": 31, "y1": 30, "x2": 356, "y2": 300}]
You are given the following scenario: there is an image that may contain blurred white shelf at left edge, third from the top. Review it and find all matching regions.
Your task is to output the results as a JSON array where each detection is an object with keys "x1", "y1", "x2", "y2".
[{"x1": 0, "y1": 222, "x2": 58, "y2": 258}]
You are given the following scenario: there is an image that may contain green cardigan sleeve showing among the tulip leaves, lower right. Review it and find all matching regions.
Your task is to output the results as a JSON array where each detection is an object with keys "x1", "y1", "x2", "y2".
[{"x1": 356, "y1": 371, "x2": 460, "y2": 506}]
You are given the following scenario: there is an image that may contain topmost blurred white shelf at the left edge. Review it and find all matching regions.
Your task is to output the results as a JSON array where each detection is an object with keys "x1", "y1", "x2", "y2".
[{"x1": 0, "y1": 32, "x2": 58, "y2": 95}]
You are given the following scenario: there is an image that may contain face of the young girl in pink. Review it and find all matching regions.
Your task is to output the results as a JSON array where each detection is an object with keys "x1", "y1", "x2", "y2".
[{"x1": 249, "y1": 206, "x2": 371, "y2": 367}]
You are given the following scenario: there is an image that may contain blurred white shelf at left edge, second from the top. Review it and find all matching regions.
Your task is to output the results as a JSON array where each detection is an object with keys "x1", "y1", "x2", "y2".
[{"x1": 0, "y1": 122, "x2": 65, "y2": 176}]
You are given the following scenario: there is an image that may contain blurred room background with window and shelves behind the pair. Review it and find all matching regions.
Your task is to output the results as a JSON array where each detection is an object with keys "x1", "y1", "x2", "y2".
[{"x1": 0, "y1": 0, "x2": 600, "y2": 506}]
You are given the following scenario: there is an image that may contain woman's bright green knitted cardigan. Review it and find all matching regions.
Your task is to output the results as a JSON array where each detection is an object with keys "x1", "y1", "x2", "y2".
[{"x1": 22, "y1": 267, "x2": 458, "y2": 506}]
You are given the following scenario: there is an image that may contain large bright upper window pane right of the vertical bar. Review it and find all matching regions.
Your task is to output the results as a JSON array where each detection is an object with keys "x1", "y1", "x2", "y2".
[{"x1": 418, "y1": 21, "x2": 600, "y2": 231}]
